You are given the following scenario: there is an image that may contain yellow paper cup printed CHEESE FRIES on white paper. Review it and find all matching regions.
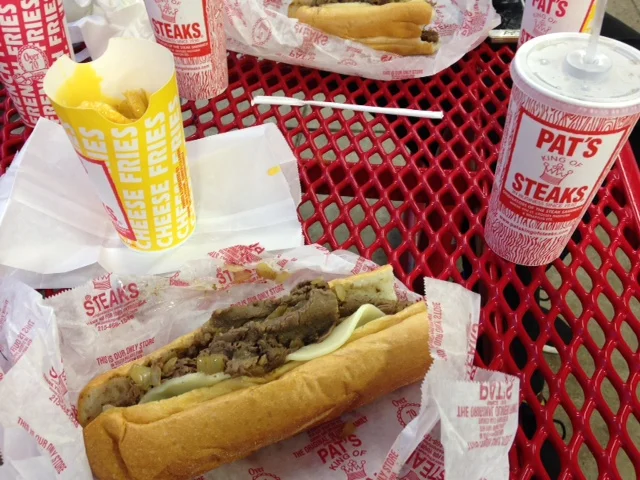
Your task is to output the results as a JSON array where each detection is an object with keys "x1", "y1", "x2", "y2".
[{"x1": 44, "y1": 38, "x2": 196, "y2": 252}]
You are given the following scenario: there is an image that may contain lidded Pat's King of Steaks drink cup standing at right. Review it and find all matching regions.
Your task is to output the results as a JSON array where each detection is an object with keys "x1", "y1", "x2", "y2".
[{"x1": 485, "y1": 33, "x2": 640, "y2": 266}]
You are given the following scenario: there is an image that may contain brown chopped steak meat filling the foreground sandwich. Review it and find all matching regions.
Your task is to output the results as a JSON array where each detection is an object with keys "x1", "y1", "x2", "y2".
[{"x1": 126, "y1": 280, "x2": 408, "y2": 404}]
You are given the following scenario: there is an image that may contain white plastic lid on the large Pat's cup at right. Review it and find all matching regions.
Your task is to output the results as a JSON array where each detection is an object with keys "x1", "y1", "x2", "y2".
[{"x1": 514, "y1": 33, "x2": 640, "y2": 108}]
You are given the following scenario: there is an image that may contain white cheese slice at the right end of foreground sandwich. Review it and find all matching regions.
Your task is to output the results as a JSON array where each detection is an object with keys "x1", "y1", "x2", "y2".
[{"x1": 287, "y1": 304, "x2": 385, "y2": 362}]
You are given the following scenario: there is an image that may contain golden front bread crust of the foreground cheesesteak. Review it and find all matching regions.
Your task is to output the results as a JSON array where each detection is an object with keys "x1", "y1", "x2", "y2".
[{"x1": 84, "y1": 303, "x2": 432, "y2": 480}]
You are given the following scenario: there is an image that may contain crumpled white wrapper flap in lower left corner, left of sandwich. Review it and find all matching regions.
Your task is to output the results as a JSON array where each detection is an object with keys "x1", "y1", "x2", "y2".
[{"x1": 0, "y1": 278, "x2": 91, "y2": 480}]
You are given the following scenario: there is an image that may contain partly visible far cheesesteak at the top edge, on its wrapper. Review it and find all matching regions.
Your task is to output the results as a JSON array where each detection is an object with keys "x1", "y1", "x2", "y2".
[{"x1": 289, "y1": 0, "x2": 440, "y2": 55}]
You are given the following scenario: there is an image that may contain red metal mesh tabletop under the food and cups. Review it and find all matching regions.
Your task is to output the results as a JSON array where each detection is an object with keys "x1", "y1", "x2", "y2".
[{"x1": 0, "y1": 44, "x2": 640, "y2": 479}]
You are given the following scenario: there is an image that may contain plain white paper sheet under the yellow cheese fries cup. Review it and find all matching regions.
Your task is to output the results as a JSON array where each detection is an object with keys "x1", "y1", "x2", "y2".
[{"x1": 0, "y1": 119, "x2": 304, "y2": 288}]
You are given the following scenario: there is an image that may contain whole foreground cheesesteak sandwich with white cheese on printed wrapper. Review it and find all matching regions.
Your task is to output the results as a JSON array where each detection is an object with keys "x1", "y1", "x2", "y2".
[{"x1": 78, "y1": 266, "x2": 431, "y2": 480}]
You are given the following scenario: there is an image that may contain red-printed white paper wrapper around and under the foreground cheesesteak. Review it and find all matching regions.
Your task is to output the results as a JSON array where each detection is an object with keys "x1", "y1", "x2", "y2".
[{"x1": 0, "y1": 245, "x2": 519, "y2": 480}]
